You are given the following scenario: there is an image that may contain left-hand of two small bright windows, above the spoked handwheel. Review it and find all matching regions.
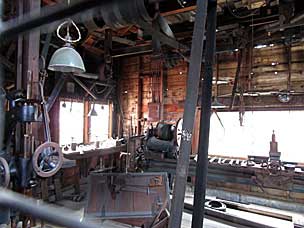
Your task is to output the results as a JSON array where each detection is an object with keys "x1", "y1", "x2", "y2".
[{"x1": 59, "y1": 101, "x2": 84, "y2": 145}]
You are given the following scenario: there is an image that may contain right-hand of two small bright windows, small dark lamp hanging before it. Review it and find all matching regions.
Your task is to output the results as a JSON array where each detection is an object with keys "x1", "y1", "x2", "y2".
[{"x1": 89, "y1": 104, "x2": 109, "y2": 142}]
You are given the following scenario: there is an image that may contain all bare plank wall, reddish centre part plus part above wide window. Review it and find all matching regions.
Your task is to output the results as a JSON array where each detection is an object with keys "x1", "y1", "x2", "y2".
[{"x1": 120, "y1": 42, "x2": 304, "y2": 135}]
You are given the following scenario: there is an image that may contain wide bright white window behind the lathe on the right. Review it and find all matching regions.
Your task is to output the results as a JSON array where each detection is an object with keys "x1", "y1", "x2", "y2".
[{"x1": 209, "y1": 111, "x2": 304, "y2": 162}]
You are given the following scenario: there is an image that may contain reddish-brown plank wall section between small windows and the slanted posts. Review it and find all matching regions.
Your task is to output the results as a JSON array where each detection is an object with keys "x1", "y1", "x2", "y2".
[{"x1": 119, "y1": 55, "x2": 188, "y2": 135}]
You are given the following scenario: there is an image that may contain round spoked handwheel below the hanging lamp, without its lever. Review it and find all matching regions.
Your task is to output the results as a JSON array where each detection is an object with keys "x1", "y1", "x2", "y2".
[{"x1": 32, "y1": 142, "x2": 63, "y2": 177}]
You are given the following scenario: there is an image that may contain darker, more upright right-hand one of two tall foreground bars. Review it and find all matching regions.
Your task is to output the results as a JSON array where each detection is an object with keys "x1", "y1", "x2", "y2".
[{"x1": 192, "y1": 0, "x2": 217, "y2": 228}]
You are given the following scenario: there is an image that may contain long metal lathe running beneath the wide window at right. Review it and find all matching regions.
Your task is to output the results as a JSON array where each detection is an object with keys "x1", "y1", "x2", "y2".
[{"x1": 145, "y1": 133, "x2": 304, "y2": 213}]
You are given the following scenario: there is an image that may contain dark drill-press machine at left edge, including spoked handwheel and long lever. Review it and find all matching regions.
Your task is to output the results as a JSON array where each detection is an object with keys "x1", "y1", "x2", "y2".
[{"x1": 0, "y1": 73, "x2": 63, "y2": 224}]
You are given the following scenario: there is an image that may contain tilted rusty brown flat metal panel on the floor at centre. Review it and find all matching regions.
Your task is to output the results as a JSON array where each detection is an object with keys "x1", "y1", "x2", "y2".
[{"x1": 85, "y1": 173, "x2": 170, "y2": 226}]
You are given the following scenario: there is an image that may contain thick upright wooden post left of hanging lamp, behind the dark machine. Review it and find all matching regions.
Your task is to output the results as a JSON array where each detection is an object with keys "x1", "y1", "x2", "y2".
[{"x1": 16, "y1": 4, "x2": 40, "y2": 224}]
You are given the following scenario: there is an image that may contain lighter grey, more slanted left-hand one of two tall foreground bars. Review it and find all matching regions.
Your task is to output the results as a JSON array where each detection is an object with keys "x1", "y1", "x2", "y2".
[{"x1": 169, "y1": 0, "x2": 208, "y2": 228}]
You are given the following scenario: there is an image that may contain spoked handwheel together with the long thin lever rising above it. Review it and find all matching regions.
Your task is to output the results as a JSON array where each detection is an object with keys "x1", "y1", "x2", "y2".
[{"x1": 32, "y1": 74, "x2": 63, "y2": 177}]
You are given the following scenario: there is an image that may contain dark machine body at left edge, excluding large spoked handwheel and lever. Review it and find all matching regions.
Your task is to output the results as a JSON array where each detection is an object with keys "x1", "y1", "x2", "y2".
[{"x1": 0, "y1": 91, "x2": 40, "y2": 188}]
